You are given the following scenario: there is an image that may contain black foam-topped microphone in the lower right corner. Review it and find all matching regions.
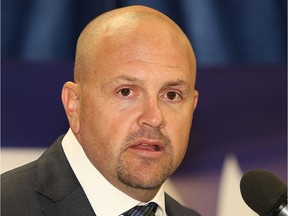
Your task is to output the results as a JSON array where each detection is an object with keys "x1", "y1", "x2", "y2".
[{"x1": 240, "y1": 170, "x2": 288, "y2": 216}]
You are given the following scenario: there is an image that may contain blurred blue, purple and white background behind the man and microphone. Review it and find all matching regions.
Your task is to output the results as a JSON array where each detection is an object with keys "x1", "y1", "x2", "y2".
[{"x1": 1, "y1": 0, "x2": 287, "y2": 216}]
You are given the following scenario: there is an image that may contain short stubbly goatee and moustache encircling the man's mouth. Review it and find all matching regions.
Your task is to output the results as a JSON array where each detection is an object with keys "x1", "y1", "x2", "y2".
[{"x1": 116, "y1": 129, "x2": 174, "y2": 190}]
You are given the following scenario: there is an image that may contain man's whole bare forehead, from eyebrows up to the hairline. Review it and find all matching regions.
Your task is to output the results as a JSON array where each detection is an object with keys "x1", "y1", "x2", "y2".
[{"x1": 81, "y1": 17, "x2": 196, "y2": 88}]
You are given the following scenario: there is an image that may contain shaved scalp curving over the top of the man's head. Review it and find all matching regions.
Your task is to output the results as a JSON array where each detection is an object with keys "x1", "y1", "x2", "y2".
[{"x1": 74, "y1": 6, "x2": 196, "y2": 83}]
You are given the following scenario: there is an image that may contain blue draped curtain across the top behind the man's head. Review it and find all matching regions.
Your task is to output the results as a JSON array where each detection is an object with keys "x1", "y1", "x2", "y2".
[{"x1": 1, "y1": 0, "x2": 287, "y2": 66}]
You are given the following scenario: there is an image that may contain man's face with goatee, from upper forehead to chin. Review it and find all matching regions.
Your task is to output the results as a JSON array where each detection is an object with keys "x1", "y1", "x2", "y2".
[{"x1": 76, "y1": 20, "x2": 197, "y2": 192}]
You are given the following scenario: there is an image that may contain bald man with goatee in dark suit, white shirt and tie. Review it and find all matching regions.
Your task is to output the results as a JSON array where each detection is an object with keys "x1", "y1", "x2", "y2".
[{"x1": 2, "y1": 6, "x2": 198, "y2": 216}]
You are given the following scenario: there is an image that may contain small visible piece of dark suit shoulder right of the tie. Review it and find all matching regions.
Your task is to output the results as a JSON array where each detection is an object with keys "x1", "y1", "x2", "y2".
[{"x1": 165, "y1": 194, "x2": 200, "y2": 216}]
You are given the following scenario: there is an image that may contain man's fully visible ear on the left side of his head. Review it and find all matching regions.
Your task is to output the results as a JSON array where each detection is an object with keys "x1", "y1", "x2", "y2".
[{"x1": 62, "y1": 82, "x2": 80, "y2": 134}]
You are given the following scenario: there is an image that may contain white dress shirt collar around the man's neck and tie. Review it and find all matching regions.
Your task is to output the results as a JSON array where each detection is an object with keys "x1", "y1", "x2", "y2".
[{"x1": 62, "y1": 129, "x2": 166, "y2": 216}]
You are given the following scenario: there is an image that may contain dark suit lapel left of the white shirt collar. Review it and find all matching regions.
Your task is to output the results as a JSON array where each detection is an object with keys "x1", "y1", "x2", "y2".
[{"x1": 37, "y1": 136, "x2": 95, "y2": 216}]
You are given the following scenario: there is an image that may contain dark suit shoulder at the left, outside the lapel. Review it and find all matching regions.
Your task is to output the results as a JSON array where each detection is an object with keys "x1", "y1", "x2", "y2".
[{"x1": 1, "y1": 136, "x2": 61, "y2": 216}]
